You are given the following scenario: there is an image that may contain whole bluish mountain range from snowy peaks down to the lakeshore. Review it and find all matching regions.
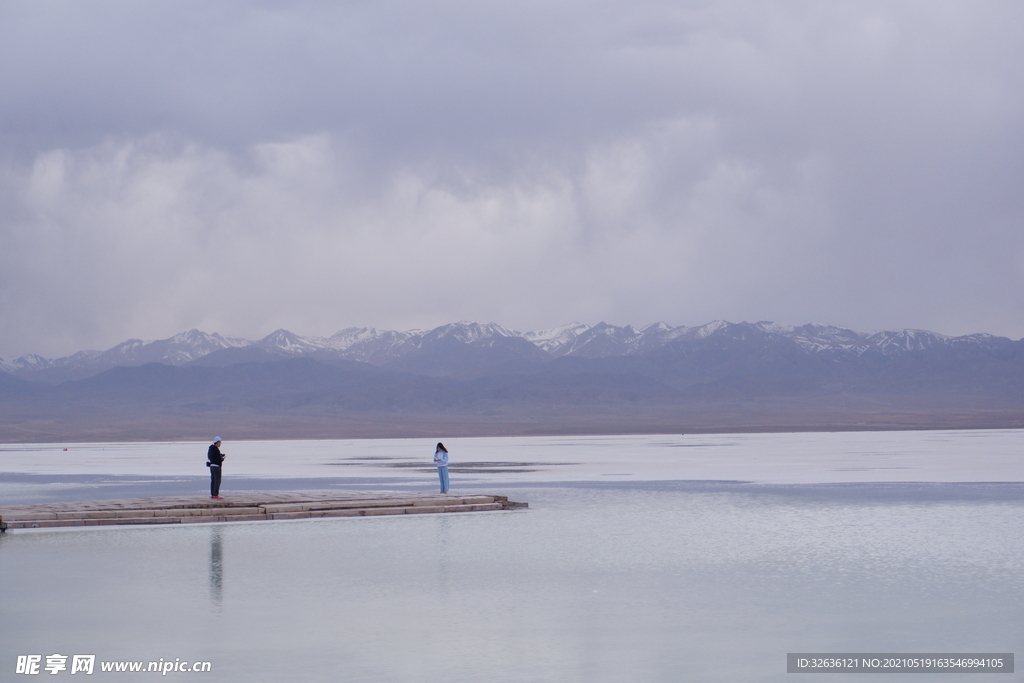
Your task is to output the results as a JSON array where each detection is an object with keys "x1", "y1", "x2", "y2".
[{"x1": 0, "y1": 321, "x2": 1024, "y2": 441}]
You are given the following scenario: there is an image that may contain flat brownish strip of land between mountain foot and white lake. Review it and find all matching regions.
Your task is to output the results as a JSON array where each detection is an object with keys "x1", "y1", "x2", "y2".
[{"x1": 0, "y1": 409, "x2": 1024, "y2": 444}]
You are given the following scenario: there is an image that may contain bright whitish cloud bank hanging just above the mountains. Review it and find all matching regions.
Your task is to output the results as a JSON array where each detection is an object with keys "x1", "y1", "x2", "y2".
[{"x1": 0, "y1": 123, "x2": 839, "y2": 353}]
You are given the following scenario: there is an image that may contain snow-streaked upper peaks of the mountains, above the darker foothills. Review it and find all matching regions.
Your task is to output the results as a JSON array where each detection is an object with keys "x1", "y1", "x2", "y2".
[{"x1": 0, "y1": 321, "x2": 1014, "y2": 384}]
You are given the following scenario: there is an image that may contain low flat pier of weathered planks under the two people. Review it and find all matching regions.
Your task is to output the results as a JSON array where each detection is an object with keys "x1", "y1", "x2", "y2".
[{"x1": 0, "y1": 492, "x2": 527, "y2": 531}]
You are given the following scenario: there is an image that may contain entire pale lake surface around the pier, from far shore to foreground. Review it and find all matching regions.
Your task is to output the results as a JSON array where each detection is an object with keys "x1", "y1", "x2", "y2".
[{"x1": 0, "y1": 431, "x2": 1024, "y2": 683}]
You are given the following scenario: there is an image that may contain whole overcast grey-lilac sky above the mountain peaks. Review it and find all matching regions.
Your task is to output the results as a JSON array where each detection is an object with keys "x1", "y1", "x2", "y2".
[{"x1": 0, "y1": 0, "x2": 1024, "y2": 359}]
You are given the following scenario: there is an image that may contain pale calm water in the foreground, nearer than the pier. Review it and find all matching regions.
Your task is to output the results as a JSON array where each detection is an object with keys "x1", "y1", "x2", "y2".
[{"x1": 0, "y1": 486, "x2": 1024, "y2": 683}]
